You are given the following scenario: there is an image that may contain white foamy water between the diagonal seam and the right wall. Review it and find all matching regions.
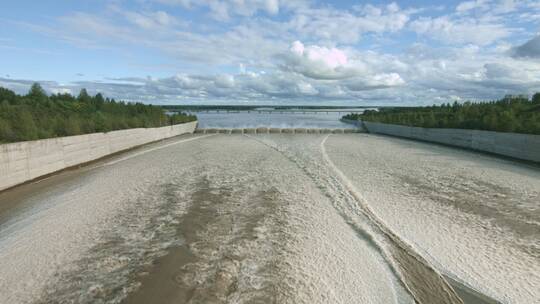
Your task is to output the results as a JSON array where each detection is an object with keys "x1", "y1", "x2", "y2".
[{"x1": 326, "y1": 135, "x2": 540, "y2": 303}]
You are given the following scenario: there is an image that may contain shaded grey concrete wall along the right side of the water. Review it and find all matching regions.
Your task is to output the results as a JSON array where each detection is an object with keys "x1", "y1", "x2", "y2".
[{"x1": 364, "y1": 121, "x2": 540, "y2": 162}]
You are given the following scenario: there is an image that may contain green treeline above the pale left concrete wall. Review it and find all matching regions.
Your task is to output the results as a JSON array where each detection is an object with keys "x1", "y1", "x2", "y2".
[{"x1": 0, "y1": 83, "x2": 196, "y2": 143}]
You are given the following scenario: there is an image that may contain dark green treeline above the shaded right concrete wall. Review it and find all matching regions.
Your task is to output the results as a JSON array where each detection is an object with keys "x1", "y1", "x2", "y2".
[{"x1": 343, "y1": 93, "x2": 540, "y2": 134}]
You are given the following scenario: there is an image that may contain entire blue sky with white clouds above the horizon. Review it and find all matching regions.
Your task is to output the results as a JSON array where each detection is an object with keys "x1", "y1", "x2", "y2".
[{"x1": 0, "y1": 0, "x2": 540, "y2": 105}]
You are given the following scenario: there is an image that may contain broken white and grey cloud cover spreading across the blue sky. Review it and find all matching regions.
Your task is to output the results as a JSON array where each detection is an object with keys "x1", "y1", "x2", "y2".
[{"x1": 7, "y1": 0, "x2": 540, "y2": 103}]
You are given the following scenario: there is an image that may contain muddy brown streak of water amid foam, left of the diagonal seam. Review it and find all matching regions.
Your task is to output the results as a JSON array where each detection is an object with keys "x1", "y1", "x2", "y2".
[{"x1": 123, "y1": 179, "x2": 286, "y2": 304}]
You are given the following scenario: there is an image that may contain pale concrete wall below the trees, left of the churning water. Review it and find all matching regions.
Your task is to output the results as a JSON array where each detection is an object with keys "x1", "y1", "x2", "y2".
[{"x1": 0, "y1": 122, "x2": 197, "y2": 191}]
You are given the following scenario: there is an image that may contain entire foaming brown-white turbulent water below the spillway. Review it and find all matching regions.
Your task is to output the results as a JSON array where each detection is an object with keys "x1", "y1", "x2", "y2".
[{"x1": 0, "y1": 134, "x2": 540, "y2": 303}]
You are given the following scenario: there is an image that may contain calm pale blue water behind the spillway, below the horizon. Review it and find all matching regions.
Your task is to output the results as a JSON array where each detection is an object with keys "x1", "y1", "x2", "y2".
[{"x1": 194, "y1": 109, "x2": 364, "y2": 129}]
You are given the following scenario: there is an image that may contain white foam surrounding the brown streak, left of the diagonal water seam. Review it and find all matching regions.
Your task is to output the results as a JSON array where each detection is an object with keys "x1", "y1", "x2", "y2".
[{"x1": 0, "y1": 135, "x2": 422, "y2": 304}]
